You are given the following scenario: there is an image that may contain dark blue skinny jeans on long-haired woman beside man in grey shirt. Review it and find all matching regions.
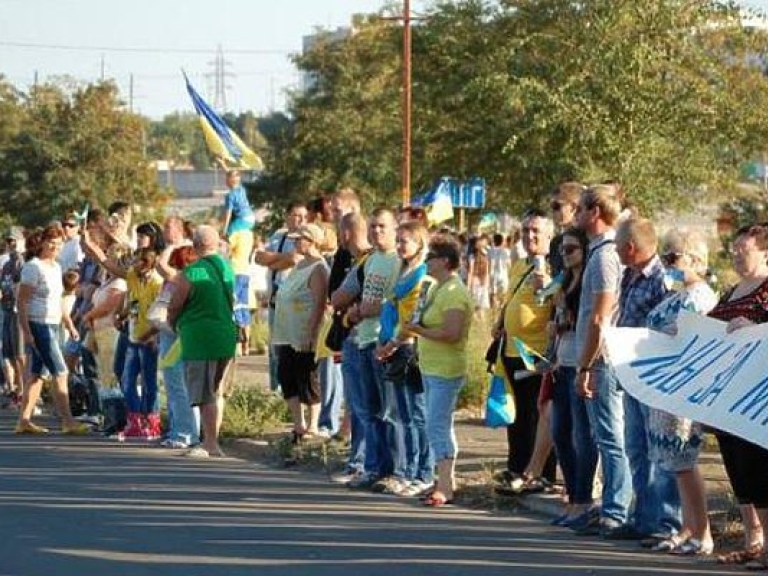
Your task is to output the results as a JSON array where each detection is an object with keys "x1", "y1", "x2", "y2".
[{"x1": 551, "y1": 366, "x2": 597, "y2": 504}]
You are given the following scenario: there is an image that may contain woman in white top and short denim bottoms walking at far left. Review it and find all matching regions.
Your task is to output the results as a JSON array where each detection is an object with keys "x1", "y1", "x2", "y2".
[{"x1": 16, "y1": 225, "x2": 88, "y2": 434}]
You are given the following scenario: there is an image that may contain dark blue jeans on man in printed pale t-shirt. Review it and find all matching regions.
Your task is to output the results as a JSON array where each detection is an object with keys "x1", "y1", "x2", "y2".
[{"x1": 360, "y1": 344, "x2": 405, "y2": 478}]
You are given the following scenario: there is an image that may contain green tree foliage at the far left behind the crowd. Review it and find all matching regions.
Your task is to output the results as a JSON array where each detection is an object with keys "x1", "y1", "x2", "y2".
[{"x1": 0, "y1": 79, "x2": 164, "y2": 226}]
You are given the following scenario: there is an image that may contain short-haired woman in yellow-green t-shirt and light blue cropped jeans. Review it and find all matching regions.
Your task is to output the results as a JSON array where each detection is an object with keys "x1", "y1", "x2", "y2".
[{"x1": 405, "y1": 236, "x2": 472, "y2": 507}]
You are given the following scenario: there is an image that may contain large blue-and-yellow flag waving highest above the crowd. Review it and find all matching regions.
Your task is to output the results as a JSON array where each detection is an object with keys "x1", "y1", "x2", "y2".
[{"x1": 184, "y1": 74, "x2": 264, "y2": 170}]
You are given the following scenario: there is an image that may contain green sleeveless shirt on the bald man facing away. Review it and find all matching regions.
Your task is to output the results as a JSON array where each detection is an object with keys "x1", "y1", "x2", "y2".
[{"x1": 178, "y1": 254, "x2": 237, "y2": 360}]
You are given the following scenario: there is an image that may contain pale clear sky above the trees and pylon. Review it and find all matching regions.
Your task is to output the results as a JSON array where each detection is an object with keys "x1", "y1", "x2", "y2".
[{"x1": 0, "y1": 0, "x2": 768, "y2": 118}]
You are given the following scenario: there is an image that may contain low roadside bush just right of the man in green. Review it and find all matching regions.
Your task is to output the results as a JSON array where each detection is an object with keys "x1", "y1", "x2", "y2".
[{"x1": 221, "y1": 386, "x2": 290, "y2": 438}]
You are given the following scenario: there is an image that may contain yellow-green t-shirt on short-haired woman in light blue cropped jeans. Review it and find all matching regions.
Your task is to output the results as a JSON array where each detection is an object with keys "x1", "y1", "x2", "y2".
[{"x1": 419, "y1": 277, "x2": 473, "y2": 378}]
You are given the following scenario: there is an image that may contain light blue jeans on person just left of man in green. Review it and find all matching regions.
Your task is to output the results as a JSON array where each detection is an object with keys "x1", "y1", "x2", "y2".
[{"x1": 157, "y1": 331, "x2": 200, "y2": 445}]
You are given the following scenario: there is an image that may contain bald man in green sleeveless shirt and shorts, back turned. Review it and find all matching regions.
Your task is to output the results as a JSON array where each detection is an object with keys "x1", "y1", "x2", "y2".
[{"x1": 168, "y1": 225, "x2": 237, "y2": 458}]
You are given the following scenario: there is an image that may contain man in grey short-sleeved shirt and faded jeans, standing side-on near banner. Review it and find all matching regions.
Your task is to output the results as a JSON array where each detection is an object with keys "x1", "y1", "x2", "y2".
[{"x1": 570, "y1": 185, "x2": 632, "y2": 537}]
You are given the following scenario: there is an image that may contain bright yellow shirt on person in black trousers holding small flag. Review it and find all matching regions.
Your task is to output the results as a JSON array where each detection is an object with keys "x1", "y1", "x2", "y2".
[{"x1": 504, "y1": 259, "x2": 552, "y2": 357}]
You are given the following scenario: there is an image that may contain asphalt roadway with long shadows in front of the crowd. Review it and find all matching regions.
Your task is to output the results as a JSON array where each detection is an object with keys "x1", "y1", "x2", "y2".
[{"x1": 0, "y1": 411, "x2": 743, "y2": 576}]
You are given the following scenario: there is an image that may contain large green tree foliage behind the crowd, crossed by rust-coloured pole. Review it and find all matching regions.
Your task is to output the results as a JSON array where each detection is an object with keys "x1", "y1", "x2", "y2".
[{"x1": 268, "y1": 0, "x2": 768, "y2": 213}]
